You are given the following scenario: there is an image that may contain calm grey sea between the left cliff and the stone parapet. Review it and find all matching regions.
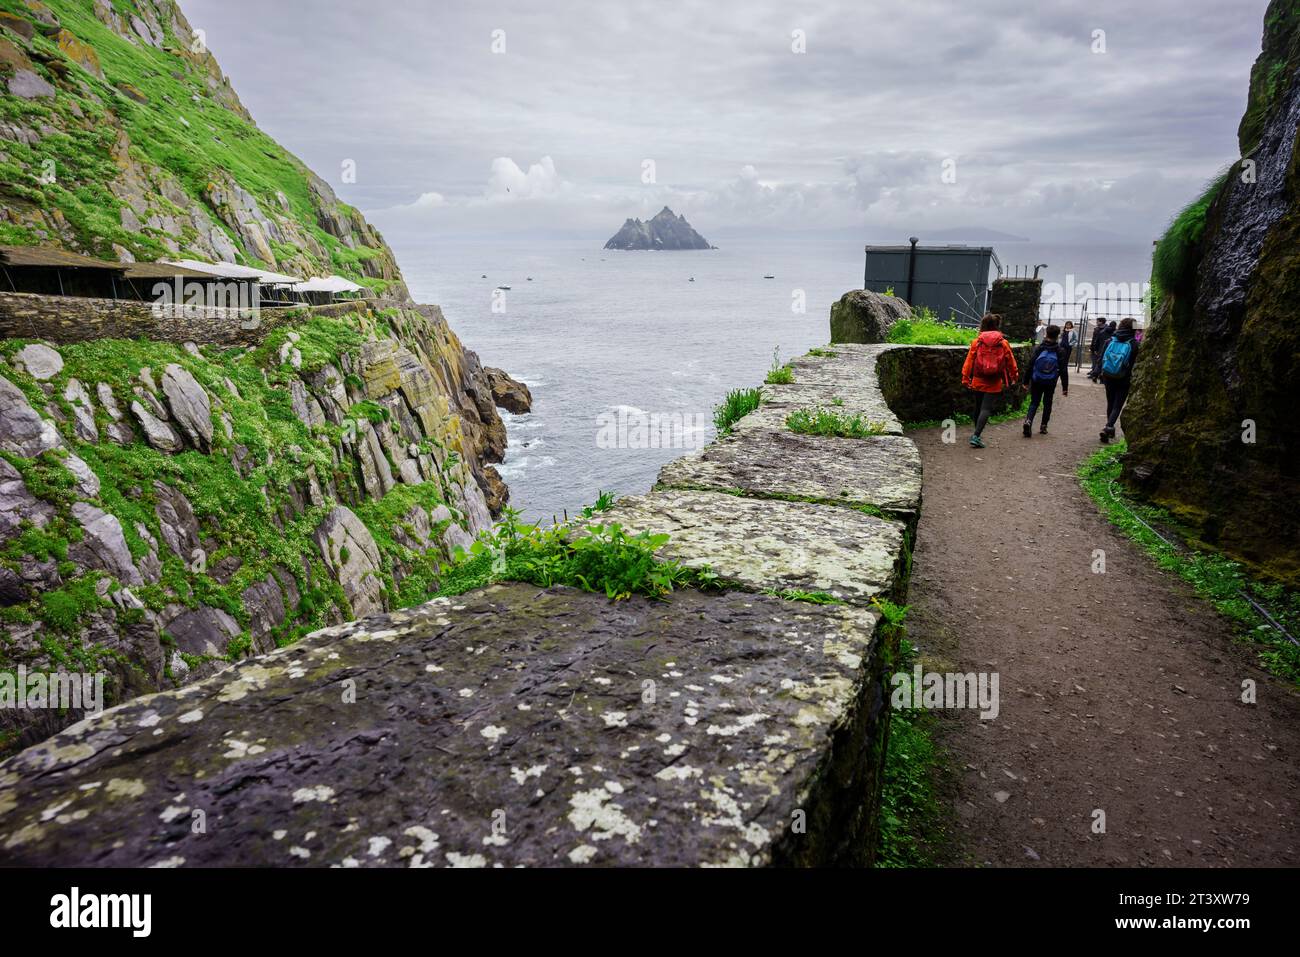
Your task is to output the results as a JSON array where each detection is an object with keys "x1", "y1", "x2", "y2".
[{"x1": 395, "y1": 238, "x2": 1151, "y2": 520}]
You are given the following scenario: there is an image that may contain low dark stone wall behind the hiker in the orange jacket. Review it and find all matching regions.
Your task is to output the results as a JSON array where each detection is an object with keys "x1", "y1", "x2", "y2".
[{"x1": 876, "y1": 346, "x2": 1034, "y2": 423}]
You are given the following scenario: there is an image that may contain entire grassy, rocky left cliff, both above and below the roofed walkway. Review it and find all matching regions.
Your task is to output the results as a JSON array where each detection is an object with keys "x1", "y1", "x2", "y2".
[{"x1": 0, "y1": 0, "x2": 528, "y2": 753}]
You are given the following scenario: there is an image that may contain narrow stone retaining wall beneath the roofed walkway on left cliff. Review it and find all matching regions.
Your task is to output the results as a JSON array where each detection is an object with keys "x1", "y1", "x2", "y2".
[{"x1": 0, "y1": 293, "x2": 377, "y2": 348}]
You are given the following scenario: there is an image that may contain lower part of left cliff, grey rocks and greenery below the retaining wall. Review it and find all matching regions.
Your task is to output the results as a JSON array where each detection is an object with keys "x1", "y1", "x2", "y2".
[{"x1": 0, "y1": 300, "x2": 520, "y2": 752}]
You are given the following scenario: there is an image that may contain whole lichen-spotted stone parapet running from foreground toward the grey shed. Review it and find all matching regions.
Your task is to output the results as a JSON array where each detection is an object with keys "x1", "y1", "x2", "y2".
[{"x1": 0, "y1": 346, "x2": 933, "y2": 867}]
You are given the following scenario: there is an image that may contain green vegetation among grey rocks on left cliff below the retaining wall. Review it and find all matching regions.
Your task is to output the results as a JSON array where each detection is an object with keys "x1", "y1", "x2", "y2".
[{"x1": 0, "y1": 310, "x2": 475, "y2": 686}]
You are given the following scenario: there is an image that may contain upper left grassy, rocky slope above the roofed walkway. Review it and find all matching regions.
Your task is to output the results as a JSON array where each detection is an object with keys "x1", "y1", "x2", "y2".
[{"x1": 0, "y1": 0, "x2": 406, "y2": 289}]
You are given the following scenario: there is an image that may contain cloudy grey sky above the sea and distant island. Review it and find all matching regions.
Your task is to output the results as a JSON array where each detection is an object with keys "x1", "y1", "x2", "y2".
[{"x1": 182, "y1": 0, "x2": 1266, "y2": 241}]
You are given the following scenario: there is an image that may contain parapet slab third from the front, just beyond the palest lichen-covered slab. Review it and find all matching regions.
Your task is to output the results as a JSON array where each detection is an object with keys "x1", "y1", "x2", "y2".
[{"x1": 659, "y1": 428, "x2": 920, "y2": 524}]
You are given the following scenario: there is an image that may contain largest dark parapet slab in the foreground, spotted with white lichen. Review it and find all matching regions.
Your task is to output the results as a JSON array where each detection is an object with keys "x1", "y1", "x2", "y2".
[{"x1": 0, "y1": 582, "x2": 885, "y2": 867}]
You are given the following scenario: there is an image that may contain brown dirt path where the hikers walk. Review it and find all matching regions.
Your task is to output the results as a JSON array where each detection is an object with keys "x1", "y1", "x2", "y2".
[{"x1": 907, "y1": 380, "x2": 1300, "y2": 866}]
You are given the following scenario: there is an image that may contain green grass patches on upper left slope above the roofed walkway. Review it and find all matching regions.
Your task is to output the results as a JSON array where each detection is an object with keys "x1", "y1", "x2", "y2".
[{"x1": 0, "y1": 0, "x2": 387, "y2": 283}]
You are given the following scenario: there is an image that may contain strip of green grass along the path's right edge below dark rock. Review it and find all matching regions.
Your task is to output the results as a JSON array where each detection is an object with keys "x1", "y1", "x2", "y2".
[{"x1": 1079, "y1": 442, "x2": 1300, "y2": 684}]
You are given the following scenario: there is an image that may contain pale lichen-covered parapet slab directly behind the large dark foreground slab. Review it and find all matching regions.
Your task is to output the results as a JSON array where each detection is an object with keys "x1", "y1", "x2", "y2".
[{"x1": 602, "y1": 490, "x2": 906, "y2": 602}]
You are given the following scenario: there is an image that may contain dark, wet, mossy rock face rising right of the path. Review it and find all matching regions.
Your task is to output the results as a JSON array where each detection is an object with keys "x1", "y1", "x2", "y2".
[{"x1": 1123, "y1": 0, "x2": 1300, "y2": 585}]
